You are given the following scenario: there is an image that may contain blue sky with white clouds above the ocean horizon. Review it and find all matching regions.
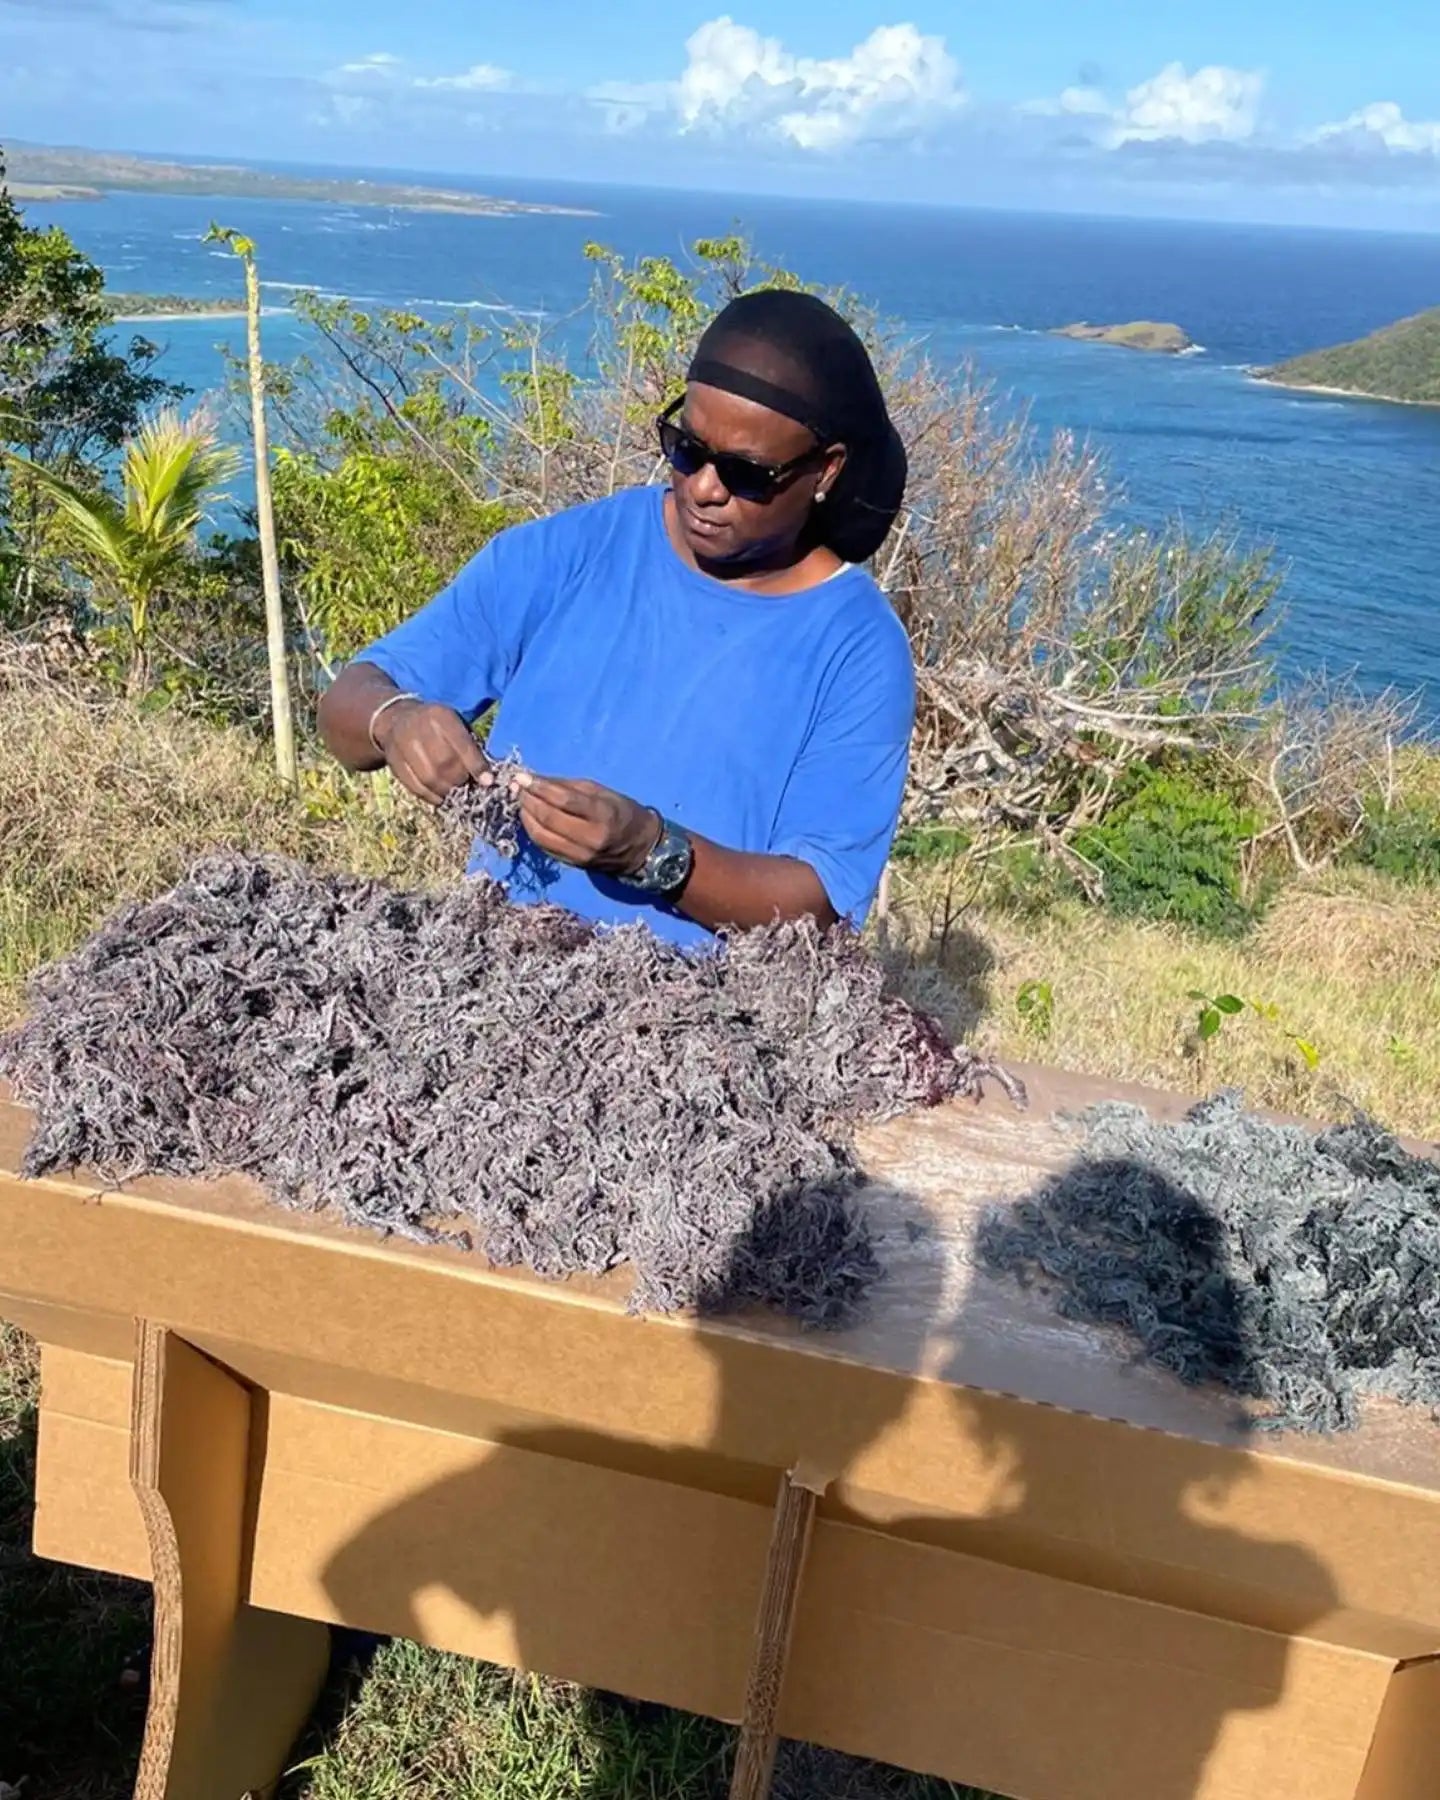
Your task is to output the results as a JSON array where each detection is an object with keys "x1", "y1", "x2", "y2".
[{"x1": 0, "y1": 0, "x2": 1440, "y2": 229}]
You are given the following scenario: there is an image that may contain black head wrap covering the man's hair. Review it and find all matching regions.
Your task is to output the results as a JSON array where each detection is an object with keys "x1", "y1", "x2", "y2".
[{"x1": 686, "y1": 288, "x2": 907, "y2": 562}]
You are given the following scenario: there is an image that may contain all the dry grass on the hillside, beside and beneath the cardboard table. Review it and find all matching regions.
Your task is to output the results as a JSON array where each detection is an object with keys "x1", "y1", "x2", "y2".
[{"x1": 0, "y1": 684, "x2": 1440, "y2": 1800}]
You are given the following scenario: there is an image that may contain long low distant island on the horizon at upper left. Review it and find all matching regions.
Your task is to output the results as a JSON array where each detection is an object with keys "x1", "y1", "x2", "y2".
[{"x1": 7, "y1": 144, "x2": 596, "y2": 218}]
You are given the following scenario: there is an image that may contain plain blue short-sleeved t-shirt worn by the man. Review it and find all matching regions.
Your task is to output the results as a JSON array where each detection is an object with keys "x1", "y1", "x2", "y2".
[{"x1": 358, "y1": 488, "x2": 914, "y2": 945}]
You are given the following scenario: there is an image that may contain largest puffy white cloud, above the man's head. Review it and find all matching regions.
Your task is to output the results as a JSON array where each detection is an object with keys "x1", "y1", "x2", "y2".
[{"x1": 673, "y1": 16, "x2": 965, "y2": 151}]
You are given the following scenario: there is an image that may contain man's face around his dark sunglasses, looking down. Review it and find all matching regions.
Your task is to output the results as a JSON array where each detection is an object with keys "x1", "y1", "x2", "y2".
[{"x1": 671, "y1": 382, "x2": 839, "y2": 563}]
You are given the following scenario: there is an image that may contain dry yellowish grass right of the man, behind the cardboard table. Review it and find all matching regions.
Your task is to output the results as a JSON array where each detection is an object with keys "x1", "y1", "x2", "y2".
[{"x1": 895, "y1": 869, "x2": 1440, "y2": 1138}]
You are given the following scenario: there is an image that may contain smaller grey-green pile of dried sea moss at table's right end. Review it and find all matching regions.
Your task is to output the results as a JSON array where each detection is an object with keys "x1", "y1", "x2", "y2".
[{"x1": 979, "y1": 1093, "x2": 1440, "y2": 1431}]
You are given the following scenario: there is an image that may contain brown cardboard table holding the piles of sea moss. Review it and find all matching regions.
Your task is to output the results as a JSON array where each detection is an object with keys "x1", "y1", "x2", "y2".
[{"x1": 0, "y1": 1075, "x2": 1440, "y2": 1800}]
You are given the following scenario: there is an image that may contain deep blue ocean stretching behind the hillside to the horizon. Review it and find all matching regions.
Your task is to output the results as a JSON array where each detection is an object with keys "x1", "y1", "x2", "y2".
[{"x1": 27, "y1": 171, "x2": 1440, "y2": 731}]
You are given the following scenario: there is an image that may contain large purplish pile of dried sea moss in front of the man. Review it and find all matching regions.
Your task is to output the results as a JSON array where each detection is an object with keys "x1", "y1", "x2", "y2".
[{"x1": 0, "y1": 855, "x2": 1015, "y2": 1323}]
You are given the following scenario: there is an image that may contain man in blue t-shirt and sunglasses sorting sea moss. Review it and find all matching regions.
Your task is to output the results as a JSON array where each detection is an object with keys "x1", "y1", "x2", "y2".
[{"x1": 320, "y1": 292, "x2": 914, "y2": 947}]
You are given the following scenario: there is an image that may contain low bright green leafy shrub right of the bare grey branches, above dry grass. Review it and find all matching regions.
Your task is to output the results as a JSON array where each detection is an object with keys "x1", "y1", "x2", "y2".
[{"x1": 1075, "y1": 769, "x2": 1260, "y2": 936}]
